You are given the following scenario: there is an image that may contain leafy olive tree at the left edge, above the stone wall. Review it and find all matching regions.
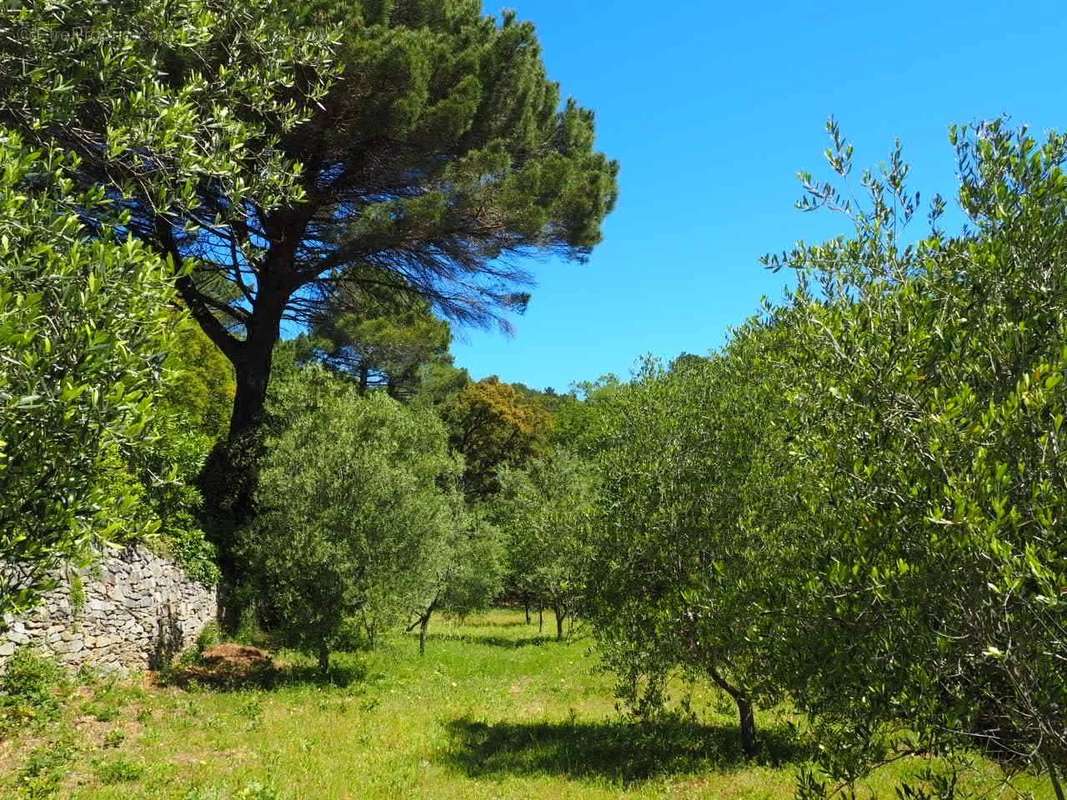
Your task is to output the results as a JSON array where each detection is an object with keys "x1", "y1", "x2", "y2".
[{"x1": 0, "y1": 129, "x2": 176, "y2": 613}]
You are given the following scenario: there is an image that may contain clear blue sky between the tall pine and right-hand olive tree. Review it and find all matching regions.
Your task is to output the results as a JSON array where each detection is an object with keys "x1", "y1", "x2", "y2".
[{"x1": 453, "y1": 0, "x2": 1067, "y2": 389}]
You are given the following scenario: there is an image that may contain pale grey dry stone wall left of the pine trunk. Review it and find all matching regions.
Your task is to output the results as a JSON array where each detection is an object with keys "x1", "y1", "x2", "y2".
[{"x1": 0, "y1": 545, "x2": 218, "y2": 672}]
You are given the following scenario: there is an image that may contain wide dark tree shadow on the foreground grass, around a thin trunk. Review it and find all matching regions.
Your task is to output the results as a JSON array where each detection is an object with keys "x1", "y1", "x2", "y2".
[{"x1": 445, "y1": 719, "x2": 806, "y2": 784}]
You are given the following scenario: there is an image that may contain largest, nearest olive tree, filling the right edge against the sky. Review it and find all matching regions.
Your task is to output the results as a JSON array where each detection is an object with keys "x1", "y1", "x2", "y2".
[{"x1": 745, "y1": 122, "x2": 1067, "y2": 797}]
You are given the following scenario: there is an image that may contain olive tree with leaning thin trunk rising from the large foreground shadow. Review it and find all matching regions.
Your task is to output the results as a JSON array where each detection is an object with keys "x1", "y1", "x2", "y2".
[{"x1": 585, "y1": 343, "x2": 793, "y2": 755}]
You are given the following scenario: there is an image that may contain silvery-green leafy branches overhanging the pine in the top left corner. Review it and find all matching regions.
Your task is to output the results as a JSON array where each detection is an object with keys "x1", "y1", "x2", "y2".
[{"x1": 0, "y1": 0, "x2": 336, "y2": 213}]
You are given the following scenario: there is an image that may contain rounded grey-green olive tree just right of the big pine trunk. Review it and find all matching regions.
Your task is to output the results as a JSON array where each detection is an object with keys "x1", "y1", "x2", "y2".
[{"x1": 241, "y1": 367, "x2": 458, "y2": 671}]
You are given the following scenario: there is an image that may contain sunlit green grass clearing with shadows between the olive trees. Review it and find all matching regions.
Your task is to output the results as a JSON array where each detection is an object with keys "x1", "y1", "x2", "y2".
[{"x1": 0, "y1": 611, "x2": 1047, "y2": 800}]
